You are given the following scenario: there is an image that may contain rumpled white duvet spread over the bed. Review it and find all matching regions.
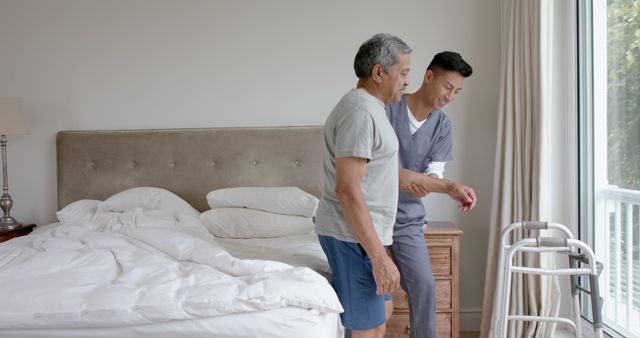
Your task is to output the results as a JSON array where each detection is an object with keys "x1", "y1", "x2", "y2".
[{"x1": 0, "y1": 208, "x2": 342, "y2": 329}]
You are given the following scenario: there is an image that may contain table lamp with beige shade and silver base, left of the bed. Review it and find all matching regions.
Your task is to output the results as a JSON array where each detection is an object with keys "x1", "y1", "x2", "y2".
[{"x1": 0, "y1": 97, "x2": 30, "y2": 231}]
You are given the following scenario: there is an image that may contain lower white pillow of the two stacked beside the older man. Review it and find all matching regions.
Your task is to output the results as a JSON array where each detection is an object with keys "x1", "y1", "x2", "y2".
[{"x1": 200, "y1": 208, "x2": 314, "y2": 238}]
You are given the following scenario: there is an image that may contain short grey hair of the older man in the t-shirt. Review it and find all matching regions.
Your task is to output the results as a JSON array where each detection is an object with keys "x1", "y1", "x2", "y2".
[{"x1": 353, "y1": 33, "x2": 412, "y2": 79}]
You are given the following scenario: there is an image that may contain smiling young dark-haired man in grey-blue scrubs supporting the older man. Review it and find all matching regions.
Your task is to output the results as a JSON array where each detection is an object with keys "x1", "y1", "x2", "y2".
[{"x1": 386, "y1": 52, "x2": 476, "y2": 338}]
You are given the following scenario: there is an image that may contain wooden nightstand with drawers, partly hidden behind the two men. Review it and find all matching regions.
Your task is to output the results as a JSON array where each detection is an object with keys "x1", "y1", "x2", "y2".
[{"x1": 385, "y1": 222, "x2": 462, "y2": 338}]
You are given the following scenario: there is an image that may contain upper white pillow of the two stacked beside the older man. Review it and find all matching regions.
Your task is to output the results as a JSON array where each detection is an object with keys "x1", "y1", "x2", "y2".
[{"x1": 207, "y1": 187, "x2": 318, "y2": 217}]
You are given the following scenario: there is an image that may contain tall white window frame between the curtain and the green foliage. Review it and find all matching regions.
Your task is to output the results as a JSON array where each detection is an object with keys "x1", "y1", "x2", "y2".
[{"x1": 577, "y1": 0, "x2": 640, "y2": 338}]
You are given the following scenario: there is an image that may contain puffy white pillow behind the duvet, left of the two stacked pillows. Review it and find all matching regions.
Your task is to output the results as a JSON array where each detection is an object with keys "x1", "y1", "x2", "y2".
[{"x1": 97, "y1": 187, "x2": 200, "y2": 218}]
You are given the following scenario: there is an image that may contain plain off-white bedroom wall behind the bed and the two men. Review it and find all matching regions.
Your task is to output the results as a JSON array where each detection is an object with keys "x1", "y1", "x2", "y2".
[{"x1": 0, "y1": 0, "x2": 499, "y2": 326}]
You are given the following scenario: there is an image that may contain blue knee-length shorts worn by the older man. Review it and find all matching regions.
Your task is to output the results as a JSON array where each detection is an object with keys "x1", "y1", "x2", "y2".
[{"x1": 318, "y1": 235, "x2": 391, "y2": 330}]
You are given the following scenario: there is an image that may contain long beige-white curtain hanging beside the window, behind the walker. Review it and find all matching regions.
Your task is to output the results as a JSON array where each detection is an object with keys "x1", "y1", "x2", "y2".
[{"x1": 480, "y1": 0, "x2": 559, "y2": 338}]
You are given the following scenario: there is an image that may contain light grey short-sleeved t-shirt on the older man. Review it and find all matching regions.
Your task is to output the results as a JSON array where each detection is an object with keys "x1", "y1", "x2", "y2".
[{"x1": 315, "y1": 89, "x2": 398, "y2": 245}]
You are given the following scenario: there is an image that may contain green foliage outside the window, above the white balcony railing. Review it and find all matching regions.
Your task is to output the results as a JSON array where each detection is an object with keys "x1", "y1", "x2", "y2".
[{"x1": 607, "y1": 0, "x2": 640, "y2": 190}]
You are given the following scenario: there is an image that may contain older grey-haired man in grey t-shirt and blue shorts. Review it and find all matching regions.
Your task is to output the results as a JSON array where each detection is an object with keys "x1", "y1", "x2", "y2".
[{"x1": 315, "y1": 34, "x2": 411, "y2": 338}]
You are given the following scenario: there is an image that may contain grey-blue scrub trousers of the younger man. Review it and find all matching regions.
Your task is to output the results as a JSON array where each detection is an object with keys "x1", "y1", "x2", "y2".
[{"x1": 390, "y1": 223, "x2": 436, "y2": 338}]
